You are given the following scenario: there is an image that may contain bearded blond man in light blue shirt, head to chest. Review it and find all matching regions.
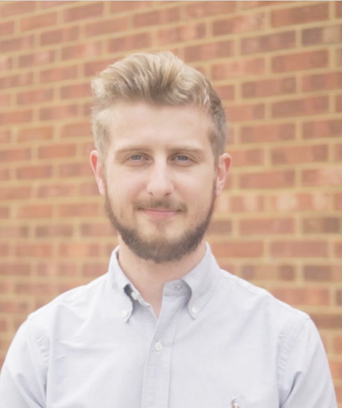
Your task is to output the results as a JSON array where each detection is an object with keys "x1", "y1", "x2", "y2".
[{"x1": 0, "y1": 53, "x2": 337, "y2": 408}]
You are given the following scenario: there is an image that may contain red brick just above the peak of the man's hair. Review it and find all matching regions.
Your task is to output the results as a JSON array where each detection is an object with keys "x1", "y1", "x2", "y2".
[{"x1": 157, "y1": 23, "x2": 206, "y2": 45}]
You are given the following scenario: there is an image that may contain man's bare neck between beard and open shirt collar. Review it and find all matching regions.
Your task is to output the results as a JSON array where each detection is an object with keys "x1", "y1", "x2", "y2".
[{"x1": 118, "y1": 236, "x2": 206, "y2": 316}]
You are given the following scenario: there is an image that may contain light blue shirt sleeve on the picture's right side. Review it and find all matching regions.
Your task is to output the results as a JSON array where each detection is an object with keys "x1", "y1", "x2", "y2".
[{"x1": 280, "y1": 319, "x2": 337, "y2": 408}]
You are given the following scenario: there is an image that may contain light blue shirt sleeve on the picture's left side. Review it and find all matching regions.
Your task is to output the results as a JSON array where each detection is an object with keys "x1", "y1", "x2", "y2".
[{"x1": 0, "y1": 320, "x2": 47, "y2": 408}]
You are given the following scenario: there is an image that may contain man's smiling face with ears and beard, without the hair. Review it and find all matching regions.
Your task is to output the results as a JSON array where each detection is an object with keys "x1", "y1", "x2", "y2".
[{"x1": 91, "y1": 103, "x2": 229, "y2": 263}]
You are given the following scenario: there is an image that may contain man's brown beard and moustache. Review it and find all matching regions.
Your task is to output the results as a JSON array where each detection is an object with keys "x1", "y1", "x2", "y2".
[{"x1": 105, "y1": 189, "x2": 215, "y2": 264}]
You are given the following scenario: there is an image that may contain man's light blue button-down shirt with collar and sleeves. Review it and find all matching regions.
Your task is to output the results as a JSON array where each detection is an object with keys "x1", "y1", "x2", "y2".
[{"x1": 0, "y1": 246, "x2": 337, "y2": 408}]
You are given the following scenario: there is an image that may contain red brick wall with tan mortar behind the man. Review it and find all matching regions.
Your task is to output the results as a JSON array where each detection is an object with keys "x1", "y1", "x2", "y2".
[{"x1": 0, "y1": 1, "x2": 342, "y2": 406}]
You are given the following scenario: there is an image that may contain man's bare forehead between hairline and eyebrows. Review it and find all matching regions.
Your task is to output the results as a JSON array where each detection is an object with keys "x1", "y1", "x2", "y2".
[{"x1": 106, "y1": 102, "x2": 211, "y2": 149}]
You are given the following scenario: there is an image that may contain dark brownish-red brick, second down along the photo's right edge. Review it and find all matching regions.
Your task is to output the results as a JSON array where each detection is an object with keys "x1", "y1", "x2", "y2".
[{"x1": 302, "y1": 24, "x2": 342, "y2": 46}]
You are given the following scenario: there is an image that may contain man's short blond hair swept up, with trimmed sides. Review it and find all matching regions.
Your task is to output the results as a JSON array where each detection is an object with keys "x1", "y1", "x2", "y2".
[{"x1": 91, "y1": 52, "x2": 227, "y2": 161}]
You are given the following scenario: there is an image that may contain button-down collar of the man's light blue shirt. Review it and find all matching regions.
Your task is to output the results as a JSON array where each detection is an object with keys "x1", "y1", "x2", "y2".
[{"x1": 109, "y1": 243, "x2": 220, "y2": 321}]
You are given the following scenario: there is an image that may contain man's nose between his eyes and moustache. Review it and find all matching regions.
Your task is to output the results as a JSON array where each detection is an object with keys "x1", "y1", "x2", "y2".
[{"x1": 146, "y1": 162, "x2": 174, "y2": 199}]
